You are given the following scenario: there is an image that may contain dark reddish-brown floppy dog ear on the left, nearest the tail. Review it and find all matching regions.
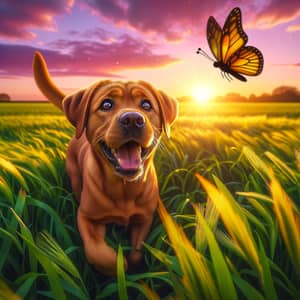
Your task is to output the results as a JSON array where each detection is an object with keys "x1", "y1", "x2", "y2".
[{"x1": 62, "y1": 88, "x2": 95, "y2": 138}]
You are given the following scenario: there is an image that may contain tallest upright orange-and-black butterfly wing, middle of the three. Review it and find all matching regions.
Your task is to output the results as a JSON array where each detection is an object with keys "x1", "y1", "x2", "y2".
[{"x1": 220, "y1": 7, "x2": 248, "y2": 64}]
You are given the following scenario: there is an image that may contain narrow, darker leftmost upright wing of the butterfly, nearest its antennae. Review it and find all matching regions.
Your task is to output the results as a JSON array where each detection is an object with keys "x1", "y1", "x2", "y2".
[{"x1": 206, "y1": 16, "x2": 222, "y2": 61}]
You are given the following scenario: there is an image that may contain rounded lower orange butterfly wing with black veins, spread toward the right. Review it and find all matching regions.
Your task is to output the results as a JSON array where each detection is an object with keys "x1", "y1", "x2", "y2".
[{"x1": 227, "y1": 46, "x2": 264, "y2": 76}]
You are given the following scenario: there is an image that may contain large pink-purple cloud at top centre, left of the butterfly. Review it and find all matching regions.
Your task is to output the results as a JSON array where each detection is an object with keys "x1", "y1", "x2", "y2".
[{"x1": 87, "y1": 0, "x2": 233, "y2": 41}]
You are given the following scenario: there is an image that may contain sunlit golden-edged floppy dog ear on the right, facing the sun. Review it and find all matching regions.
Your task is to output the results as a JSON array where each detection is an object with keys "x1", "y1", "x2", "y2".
[{"x1": 157, "y1": 91, "x2": 178, "y2": 138}]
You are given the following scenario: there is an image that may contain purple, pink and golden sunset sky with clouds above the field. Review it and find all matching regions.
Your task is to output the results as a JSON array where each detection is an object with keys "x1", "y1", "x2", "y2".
[{"x1": 0, "y1": 0, "x2": 300, "y2": 100}]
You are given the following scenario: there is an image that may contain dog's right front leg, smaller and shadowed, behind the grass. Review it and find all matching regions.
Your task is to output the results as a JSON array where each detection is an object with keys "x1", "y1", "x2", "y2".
[{"x1": 128, "y1": 216, "x2": 153, "y2": 266}]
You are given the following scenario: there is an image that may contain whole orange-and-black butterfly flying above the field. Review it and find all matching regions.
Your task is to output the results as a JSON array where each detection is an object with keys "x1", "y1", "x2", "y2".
[{"x1": 197, "y1": 7, "x2": 264, "y2": 81}]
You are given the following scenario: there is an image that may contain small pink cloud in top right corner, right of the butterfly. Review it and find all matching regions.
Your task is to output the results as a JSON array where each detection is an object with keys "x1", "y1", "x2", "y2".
[{"x1": 255, "y1": 0, "x2": 300, "y2": 28}]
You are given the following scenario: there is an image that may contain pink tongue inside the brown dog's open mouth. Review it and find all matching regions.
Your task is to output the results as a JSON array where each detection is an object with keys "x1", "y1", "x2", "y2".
[{"x1": 116, "y1": 143, "x2": 141, "y2": 170}]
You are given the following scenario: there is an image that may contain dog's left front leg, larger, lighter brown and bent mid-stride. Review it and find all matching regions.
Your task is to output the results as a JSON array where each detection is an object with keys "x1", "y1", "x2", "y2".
[{"x1": 77, "y1": 207, "x2": 126, "y2": 276}]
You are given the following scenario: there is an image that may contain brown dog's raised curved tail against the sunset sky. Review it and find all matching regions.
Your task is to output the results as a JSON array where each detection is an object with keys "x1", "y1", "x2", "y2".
[{"x1": 33, "y1": 51, "x2": 65, "y2": 110}]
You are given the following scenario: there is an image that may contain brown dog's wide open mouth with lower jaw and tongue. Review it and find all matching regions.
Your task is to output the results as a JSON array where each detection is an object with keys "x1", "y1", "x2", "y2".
[{"x1": 99, "y1": 141, "x2": 153, "y2": 177}]
